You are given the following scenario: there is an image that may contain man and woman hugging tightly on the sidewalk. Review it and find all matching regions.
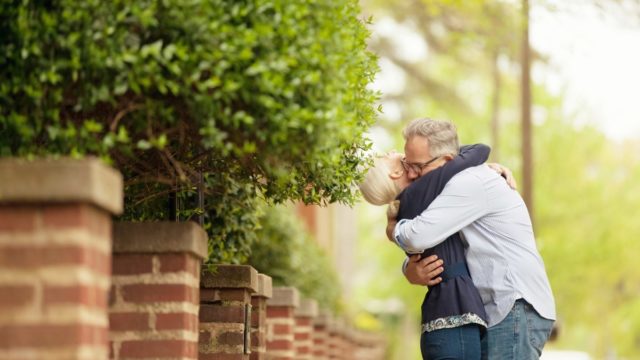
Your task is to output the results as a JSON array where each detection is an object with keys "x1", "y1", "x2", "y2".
[{"x1": 360, "y1": 119, "x2": 556, "y2": 360}]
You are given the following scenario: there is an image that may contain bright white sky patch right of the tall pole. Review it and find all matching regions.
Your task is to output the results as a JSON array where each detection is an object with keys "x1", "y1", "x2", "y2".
[{"x1": 531, "y1": 1, "x2": 640, "y2": 140}]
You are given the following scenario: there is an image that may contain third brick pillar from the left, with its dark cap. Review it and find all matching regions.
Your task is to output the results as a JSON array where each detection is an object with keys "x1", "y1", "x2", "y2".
[{"x1": 198, "y1": 265, "x2": 258, "y2": 360}]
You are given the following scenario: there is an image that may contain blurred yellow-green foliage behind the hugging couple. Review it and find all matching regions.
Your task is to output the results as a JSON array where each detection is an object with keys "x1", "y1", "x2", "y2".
[{"x1": 356, "y1": 0, "x2": 640, "y2": 359}]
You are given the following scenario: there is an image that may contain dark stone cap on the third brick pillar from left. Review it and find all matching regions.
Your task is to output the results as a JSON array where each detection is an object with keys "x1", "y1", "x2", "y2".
[{"x1": 200, "y1": 265, "x2": 258, "y2": 292}]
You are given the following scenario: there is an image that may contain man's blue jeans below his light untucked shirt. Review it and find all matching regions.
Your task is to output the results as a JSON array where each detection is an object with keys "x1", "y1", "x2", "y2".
[{"x1": 482, "y1": 299, "x2": 553, "y2": 360}]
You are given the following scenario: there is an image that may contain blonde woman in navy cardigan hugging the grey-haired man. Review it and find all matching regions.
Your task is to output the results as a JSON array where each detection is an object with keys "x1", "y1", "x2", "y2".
[{"x1": 360, "y1": 144, "x2": 509, "y2": 359}]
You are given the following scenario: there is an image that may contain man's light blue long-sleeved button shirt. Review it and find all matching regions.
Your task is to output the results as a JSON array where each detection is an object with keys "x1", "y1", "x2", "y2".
[{"x1": 394, "y1": 165, "x2": 556, "y2": 327}]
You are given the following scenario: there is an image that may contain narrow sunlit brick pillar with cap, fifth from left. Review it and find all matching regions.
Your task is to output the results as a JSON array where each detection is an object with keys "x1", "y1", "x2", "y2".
[{"x1": 267, "y1": 287, "x2": 300, "y2": 360}]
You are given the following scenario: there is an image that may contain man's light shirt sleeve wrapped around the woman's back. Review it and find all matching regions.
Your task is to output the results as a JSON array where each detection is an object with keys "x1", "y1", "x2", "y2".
[{"x1": 393, "y1": 172, "x2": 488, "y2": 253}]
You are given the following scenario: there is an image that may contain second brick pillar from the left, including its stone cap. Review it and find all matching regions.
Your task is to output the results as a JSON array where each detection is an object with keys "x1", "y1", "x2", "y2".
[{"x1": 109, "y1": 222, "x2": 207, "y2": 359}]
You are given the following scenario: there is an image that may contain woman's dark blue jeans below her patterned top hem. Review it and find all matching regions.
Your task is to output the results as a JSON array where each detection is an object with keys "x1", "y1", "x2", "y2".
[{"x1": 420, "y1": 324, "x2": 480, "y2": 360}]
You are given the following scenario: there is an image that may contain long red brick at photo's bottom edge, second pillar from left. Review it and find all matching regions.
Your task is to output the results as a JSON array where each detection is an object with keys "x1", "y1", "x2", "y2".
[{"x1": 120, "y1": 340, "x2": 198, "y2": 359}]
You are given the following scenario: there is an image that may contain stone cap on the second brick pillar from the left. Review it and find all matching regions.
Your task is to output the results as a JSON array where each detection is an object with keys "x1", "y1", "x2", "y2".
[{"x1": 113, "y1": 221, "x2": 208, "y2": 259}]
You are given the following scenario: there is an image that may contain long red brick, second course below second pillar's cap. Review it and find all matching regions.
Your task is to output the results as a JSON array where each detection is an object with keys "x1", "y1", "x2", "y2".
[{"x1": 120, "y1": 284, "x2": 198, "y2": 303}]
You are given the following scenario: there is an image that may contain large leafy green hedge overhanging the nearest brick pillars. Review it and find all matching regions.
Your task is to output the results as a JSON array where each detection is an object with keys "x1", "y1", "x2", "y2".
[{"x1": 0, "y1": 0, "x2": 377, "y2": 262}]
